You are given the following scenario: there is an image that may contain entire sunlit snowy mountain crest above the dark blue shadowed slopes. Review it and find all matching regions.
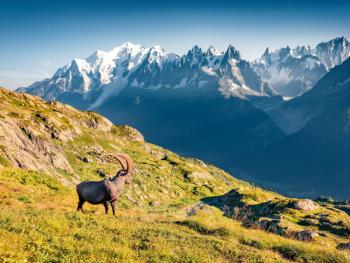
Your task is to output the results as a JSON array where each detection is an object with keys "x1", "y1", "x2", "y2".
[{"x1": 20, "y1": 37, "x2": 350, "y2": 104}]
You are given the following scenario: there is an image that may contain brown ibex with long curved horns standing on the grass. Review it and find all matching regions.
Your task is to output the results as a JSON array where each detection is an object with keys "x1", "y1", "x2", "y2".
[{"x1": 77, "y1": 153, "x2": 132, "y2": 215}]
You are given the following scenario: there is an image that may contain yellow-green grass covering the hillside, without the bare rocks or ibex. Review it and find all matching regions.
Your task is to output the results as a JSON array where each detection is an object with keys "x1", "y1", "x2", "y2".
[{"x1": 0, "y1": 89, "x2": 350, "y2": 262}]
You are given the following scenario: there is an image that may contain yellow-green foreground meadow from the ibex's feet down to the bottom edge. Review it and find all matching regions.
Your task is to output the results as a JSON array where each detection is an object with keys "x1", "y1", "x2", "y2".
[{"x1": 0, "y1": 168, "x2": 349, "y2": 262}]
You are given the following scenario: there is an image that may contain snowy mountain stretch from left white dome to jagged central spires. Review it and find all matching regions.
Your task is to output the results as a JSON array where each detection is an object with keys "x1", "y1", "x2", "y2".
[{"x1": 19, "y1": 42, "x2": 273, "y2": 108}]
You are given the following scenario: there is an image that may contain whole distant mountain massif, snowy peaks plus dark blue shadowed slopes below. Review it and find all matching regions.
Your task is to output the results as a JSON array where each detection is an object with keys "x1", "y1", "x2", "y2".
[{"x1": 17, "y1": 37, "x2": 350, "y2": 199}]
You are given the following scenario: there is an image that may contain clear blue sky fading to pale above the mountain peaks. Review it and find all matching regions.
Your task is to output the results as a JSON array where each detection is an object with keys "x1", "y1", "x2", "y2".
[{"x1": 0, "y1": 0, "x2": 350, "y2": 88}]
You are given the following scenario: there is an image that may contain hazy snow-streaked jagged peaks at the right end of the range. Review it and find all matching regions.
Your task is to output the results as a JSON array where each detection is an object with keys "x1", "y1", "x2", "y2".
[{"x1": 253, "y1": 37, "x2": 350, "y2": 97}]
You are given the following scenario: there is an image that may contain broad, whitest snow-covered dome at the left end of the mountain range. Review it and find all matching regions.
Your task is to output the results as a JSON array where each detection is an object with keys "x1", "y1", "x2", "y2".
[{"x1": 20, "y1": 42, "x2": 173, "y2": 108}]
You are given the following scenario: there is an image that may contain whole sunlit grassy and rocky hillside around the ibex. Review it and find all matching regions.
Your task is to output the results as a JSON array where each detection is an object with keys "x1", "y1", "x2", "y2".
[{"x1": 0, "y1": 89, "x2": 350, "y2": 262}]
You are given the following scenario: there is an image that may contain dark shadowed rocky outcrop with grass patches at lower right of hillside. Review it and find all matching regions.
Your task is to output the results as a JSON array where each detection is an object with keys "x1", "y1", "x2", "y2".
[{"x1": 202, "y1": 189, "x2": 350, "y2": 242}]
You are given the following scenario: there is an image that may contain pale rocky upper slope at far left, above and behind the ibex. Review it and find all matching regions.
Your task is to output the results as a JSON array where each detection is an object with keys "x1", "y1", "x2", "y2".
[{"x1": 0, "y1": 88, "x2": 123, "y2": 181}]
